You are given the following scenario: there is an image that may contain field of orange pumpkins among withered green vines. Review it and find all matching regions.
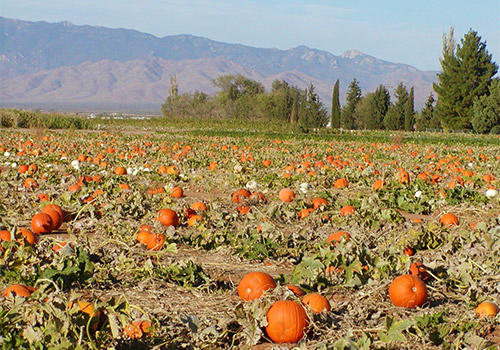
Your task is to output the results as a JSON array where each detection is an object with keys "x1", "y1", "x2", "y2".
[{"x1": 0, "y1": 129, "x2": 500, "y2": 349}]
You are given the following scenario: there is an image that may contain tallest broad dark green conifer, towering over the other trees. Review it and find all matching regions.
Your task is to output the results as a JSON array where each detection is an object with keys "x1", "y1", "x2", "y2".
[{"x1": 433, "y1": 28, "x2": 498, "y2": 130}]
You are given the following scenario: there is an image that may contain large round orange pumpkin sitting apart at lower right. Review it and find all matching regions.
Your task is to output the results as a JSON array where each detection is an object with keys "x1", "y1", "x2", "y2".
[{"x1": 389, "y1": 274, "x2": 427, "y2": 309}]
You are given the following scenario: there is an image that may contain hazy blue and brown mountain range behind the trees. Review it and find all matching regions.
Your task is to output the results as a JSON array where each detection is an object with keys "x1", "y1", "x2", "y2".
[{"x1": 0, "y1": 17, "x2": 437, "y2": 112}]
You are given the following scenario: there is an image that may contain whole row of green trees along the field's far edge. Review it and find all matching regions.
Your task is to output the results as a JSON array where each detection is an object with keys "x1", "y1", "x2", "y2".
[{"x1": 162, "y1": 28, "x2": 500, "y2": 133}]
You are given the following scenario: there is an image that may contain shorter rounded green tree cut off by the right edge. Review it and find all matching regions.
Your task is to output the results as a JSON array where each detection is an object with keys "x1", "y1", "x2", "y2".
[{"x1": 471, "y1": 78, "x2": 500, "y2": 134}]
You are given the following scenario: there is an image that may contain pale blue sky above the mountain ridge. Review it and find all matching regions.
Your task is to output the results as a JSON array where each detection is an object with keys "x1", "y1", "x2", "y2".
[{"x1": 0, "y1": 0, "x2": 500, "y2": 70}]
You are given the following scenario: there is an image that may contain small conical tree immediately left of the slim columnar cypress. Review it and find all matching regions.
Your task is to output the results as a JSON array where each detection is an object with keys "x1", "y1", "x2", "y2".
[{"x1": 299, "y1": 84, "x2": 328, "y2": 131}]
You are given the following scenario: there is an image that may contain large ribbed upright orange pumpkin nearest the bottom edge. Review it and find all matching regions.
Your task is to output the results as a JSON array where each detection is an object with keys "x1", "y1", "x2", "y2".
[{"x1": 266, "y1": 300, "x2": 309, "y2": 343}]
